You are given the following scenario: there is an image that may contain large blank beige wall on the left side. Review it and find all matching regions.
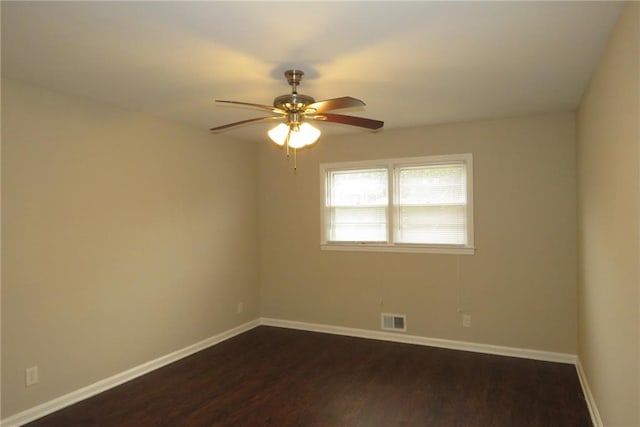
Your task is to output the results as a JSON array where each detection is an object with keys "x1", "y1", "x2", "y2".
[{"x1": 2, "y1": 81, "x2": 259, "y2": 417}]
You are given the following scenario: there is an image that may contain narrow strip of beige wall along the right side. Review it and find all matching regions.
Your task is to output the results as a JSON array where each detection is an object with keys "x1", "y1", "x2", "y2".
[{"x1": 578, "y1": 3, "x2": 640, "y2": 426}]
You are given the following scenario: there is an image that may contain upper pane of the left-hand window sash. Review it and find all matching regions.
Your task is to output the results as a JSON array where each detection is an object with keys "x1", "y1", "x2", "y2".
[{"x1": 328, "y1": 169, "x2": 388, "y2": 206}]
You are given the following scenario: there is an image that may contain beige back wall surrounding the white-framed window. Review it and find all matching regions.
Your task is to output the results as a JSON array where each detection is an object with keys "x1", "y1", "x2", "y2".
[{"x1": 259, "y1": 113, "x2": 576, "y2": 353}]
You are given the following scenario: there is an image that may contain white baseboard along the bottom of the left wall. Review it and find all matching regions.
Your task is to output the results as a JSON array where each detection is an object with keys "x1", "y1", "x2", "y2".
[{"x1": 0, "y1": 320, "x2": 260, "y2": 427}]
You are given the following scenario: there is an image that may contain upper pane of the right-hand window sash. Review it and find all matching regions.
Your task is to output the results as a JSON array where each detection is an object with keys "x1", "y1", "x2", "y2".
[{"x1": 398, "y1": 164, "x2": 467, "y2": 205}]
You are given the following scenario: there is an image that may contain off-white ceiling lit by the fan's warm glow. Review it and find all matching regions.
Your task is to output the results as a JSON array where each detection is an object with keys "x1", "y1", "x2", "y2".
[{"x1": 1, "y1": 1, "x2": 622, "y2": 139}]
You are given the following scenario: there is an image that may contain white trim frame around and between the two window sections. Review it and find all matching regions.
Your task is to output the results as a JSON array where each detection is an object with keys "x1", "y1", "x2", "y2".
[{"x1": 320, "y1": 153, "x2": 475, "y2": 255}]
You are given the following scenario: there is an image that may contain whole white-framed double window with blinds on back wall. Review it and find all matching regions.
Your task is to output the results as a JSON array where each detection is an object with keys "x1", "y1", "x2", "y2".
[{"x1": 320, "y1": 154, "x2": 473, "y2": 254}]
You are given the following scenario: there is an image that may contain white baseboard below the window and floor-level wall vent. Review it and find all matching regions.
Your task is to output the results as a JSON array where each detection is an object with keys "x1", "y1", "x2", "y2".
[{"x1": 260, "y1": 317, "x2": 576, "y2": 364}]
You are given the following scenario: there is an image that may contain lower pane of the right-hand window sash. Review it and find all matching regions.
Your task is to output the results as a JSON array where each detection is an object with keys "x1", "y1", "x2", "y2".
[{"x1": 396, "y1": 205, "x2": 467, "y2": 245}]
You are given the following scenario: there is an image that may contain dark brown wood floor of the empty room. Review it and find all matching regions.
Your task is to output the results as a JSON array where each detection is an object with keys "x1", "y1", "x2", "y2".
[{"x1": 29, "y1": 326, "x2": 591, "y2": 427}]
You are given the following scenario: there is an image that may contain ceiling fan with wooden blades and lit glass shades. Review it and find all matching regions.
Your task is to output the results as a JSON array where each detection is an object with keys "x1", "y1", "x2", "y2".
[{"x1": 210, "y1": 70, "x2": 384, "y2": 169}]
